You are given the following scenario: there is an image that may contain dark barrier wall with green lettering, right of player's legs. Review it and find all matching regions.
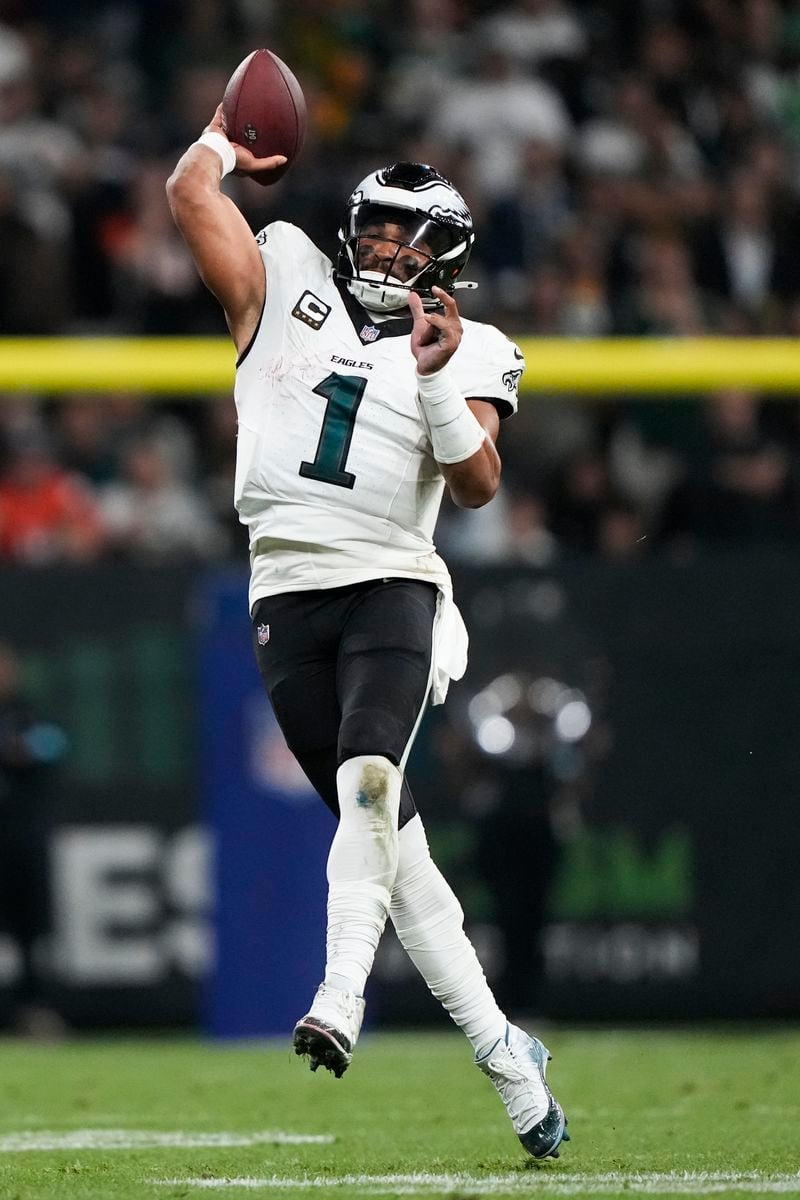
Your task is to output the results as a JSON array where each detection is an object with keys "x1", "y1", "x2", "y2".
[{"x1": 380, "y1": 554, "x2": 800, "y2": 1020}]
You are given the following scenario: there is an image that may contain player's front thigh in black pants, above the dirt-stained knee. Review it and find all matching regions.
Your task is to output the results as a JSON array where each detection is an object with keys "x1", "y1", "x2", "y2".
[{"x1": 338, "y1": 580, "x2": 437, "y2": 764}]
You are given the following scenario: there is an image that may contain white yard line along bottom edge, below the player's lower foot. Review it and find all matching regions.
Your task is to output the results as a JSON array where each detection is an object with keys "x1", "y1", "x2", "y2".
[{"x1": 150, "y1": 1169, "x2": 800, "y2": 1196}]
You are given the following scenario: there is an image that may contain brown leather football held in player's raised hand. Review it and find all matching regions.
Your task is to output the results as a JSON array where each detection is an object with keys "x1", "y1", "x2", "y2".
[{"x1": 222, "y1": 49, "x2": 306, "y2": 184}]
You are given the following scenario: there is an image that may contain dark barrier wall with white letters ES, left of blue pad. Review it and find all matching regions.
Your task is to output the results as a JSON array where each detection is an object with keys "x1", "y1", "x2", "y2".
[{"x1": 0, "y1": 565, "x2": 210, "y2": 1026}]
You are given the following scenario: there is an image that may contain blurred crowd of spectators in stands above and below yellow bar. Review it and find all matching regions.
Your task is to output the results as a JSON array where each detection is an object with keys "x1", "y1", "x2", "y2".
[{"x1": 0, "y1": 0, "x2": 800, "y2": 565}]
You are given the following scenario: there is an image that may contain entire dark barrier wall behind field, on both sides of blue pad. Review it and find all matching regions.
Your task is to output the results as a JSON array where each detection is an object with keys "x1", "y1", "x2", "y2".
[{"x1": 0, "y1": 554, "x2": 800, "y2": 1025}]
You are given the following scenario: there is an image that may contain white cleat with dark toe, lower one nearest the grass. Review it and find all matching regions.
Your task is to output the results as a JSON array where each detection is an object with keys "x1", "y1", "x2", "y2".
[{"x1": 475, "y1": 1025, "x2": 570, "y2": 1158}]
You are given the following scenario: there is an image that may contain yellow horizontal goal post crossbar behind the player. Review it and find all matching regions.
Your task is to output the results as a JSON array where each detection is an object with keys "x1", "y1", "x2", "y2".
[{"x1": 0, "y1": 337, "x2": 800, "y2": 398}]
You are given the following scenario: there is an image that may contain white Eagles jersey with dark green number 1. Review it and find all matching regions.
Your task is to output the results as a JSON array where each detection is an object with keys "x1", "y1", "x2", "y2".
[{"x1": 235, "y1": 221, "x2": 524, "y2": 608}]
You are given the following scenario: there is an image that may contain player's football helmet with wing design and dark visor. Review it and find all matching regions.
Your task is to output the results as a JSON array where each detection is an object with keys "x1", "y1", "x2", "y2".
[{"x1": 336, "y1": 162, "x2": 477, "y2": 312}]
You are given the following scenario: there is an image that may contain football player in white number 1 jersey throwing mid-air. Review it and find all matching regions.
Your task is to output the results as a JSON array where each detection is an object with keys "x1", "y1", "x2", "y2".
[{"x1": 168, "y1": 109, "x2": 567, "y2": 1158}]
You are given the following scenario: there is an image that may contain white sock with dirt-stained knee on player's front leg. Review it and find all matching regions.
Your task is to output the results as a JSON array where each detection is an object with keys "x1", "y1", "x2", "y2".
[{"x1": 325, "y1": 755, "x2": 403, "y2": 996}]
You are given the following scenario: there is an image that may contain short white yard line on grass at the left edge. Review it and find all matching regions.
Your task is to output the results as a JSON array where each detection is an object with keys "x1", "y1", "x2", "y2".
[{"x1": 0, "y1": 1129, "x2": 336, "y2": 1154}]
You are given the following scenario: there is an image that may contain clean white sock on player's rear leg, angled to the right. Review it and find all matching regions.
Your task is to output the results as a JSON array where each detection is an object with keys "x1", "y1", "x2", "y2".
[{"x1": 391, "y1": 816, "x2": 506, "y2": 1057}]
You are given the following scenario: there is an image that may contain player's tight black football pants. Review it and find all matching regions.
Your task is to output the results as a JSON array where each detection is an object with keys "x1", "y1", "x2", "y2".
[{"x1": 253, "y1": 580, "x2": 438, "y2": 828}]
